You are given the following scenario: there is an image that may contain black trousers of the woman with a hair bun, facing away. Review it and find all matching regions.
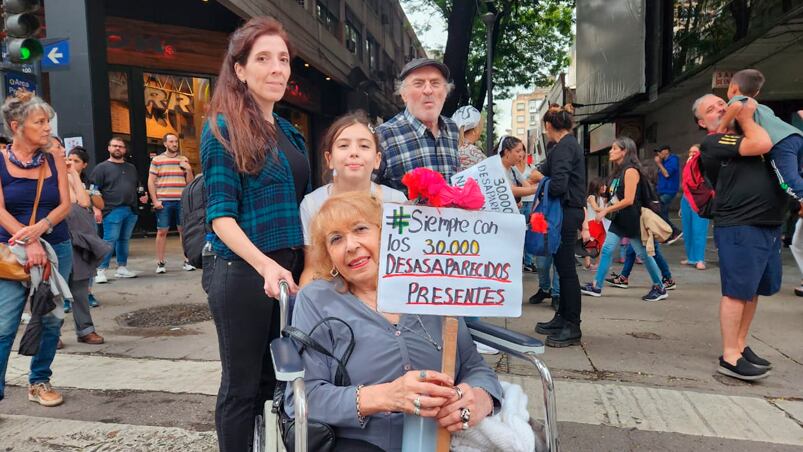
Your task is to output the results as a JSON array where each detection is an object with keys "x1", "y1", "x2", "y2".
[{"x1": 554, "y1": 207, "x2": 584, "y2": 326}]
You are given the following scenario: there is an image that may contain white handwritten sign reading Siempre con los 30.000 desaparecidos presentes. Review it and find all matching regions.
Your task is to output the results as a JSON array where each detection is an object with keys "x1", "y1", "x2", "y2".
[{"x1": 377, "y1": 203, "x2": 525, "y2": 317}]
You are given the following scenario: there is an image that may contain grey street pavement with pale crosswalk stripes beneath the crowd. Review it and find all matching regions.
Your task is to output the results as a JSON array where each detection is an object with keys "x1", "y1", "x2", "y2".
[{"x1": 0, "y1": 237, "x2": 803, "y2": 450}]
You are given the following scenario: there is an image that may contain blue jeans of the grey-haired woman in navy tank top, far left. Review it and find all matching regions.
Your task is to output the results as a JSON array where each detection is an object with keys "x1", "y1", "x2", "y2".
[{"x1": 0, "y1": 240, "x2": 72, "y2": 400}]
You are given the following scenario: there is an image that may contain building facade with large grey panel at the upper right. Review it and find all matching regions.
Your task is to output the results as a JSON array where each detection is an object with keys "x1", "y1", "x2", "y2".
[{"x1": 576, "y1": 0, "x2": 803, "y2": 180}]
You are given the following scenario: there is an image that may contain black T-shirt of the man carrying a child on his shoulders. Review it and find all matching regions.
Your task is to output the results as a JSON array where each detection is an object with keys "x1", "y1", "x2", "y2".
[{"x1": 700, "y1": 133, "x2": 786, "y2": 226}]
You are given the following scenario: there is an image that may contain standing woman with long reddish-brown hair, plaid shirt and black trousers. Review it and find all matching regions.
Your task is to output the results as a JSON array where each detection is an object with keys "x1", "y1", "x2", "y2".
[{"x1": 201, "y1": 17, "x2": 311, "y2": 452}]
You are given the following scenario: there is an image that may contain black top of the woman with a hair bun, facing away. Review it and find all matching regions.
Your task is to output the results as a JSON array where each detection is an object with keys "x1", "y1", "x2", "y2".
[{"x1": 543, "y1": 134, "x2": 586, "y2": 209}]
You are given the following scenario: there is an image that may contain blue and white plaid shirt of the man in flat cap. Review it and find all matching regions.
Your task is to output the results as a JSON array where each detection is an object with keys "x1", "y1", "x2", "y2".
[{"x1": 376, "y1": 108, "x2": 460, "y2": 193}]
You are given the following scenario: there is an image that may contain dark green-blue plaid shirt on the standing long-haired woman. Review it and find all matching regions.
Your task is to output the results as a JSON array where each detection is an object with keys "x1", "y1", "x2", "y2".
[{"x1": 201, "y1": 114, "x2": 312, "y2": 259}]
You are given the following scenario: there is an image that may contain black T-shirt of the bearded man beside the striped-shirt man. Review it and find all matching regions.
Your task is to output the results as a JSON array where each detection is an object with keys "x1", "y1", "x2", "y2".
[{"x1": 91, "y1": 160, "x2": 139, "y2": 215}]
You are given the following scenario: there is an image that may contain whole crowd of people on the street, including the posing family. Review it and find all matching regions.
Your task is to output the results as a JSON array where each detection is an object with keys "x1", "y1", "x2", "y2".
[{"x1": 0, "y1": 17, "x2": 803, "y2": 451}]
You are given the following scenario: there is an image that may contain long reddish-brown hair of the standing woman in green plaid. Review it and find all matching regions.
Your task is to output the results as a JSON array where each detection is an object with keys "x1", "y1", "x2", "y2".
[{"x1": 208, "y1": 17, "x2": 293, "y2": 175}]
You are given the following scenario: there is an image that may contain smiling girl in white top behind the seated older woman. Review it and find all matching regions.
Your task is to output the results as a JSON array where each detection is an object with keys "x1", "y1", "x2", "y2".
[{"x1": 299, "y1": 111, "x2": 407, "y2": 285}]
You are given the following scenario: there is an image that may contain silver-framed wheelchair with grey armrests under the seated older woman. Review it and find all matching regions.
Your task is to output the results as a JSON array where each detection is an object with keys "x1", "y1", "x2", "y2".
[{"x1": 253, "y1": 281, "x2": 559, "y2": 452}]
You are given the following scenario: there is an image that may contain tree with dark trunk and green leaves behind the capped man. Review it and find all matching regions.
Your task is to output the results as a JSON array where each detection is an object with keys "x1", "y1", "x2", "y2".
[{"x1": 403, "y1": 0, "x2": 575, "y2": 114}]
